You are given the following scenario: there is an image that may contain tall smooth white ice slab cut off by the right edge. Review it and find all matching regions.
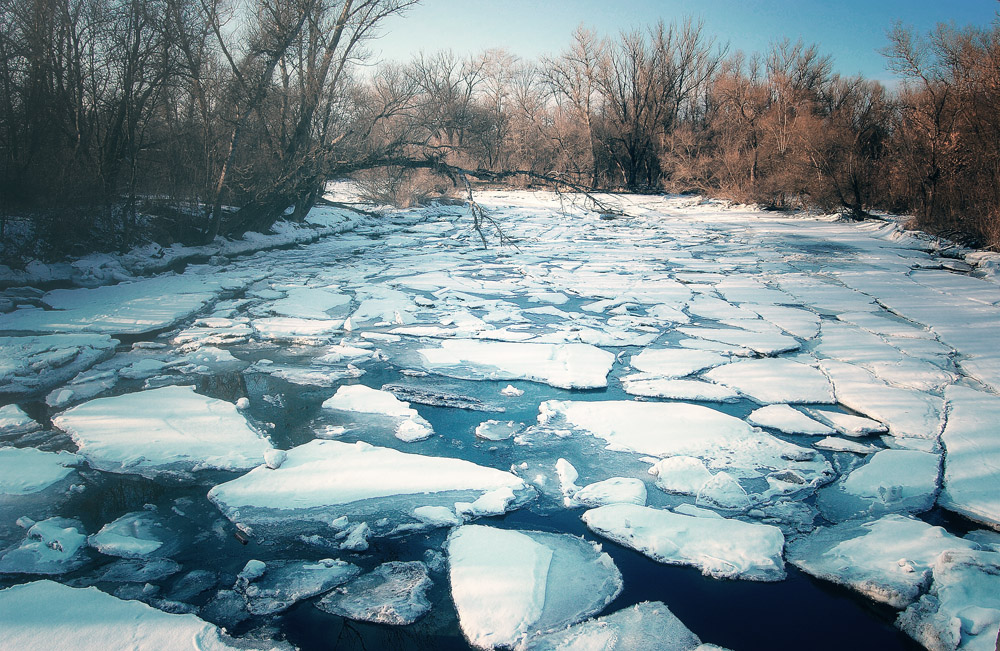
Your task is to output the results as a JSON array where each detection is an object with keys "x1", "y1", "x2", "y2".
[{"x1": 938, "y1": 386, "x2": 1000, "y2": 529}]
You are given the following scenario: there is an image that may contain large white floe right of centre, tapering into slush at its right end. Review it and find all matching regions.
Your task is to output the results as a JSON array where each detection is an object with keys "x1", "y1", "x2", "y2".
[{"x1": 538, "y1": 400, "x2": 833, "y2": 486}]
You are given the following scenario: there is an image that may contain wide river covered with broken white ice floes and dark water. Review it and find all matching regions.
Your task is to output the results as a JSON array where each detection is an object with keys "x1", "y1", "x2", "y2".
[{"x1": 0, "y1": 192, "x2": 1000, "y2": 650}]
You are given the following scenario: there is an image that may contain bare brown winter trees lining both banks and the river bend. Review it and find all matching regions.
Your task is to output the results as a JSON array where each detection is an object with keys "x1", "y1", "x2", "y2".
[{"x1": 0, "y1": 0, "x2": 1000, "y2": 262}]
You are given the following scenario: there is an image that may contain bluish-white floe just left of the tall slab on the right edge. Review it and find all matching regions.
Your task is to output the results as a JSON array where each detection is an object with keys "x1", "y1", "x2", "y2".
[{"x1": 842, "y1": 450, "x2": 941, "y2": 511}]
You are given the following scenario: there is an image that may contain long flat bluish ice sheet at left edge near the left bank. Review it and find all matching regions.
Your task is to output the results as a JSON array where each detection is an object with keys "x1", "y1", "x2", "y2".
[{"x1": 0, "y1": 274, "x2": 246, "y2": 335}]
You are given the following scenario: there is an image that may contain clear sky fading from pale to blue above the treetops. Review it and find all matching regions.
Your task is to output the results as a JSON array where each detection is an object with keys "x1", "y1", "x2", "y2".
[{"x1": 370, "y1": 0, "x2": 1000, "y2": 81}]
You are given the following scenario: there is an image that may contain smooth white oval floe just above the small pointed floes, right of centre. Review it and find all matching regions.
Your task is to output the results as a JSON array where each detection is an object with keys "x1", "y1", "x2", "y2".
[{"x1": 705, "y1": 359, "x2": 836, "y2": 404}]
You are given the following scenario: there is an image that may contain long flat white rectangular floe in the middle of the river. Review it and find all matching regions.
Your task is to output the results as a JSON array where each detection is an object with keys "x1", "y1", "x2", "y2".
[{"x1": 418, "y1": 339, "x2": 615, "y2": 389}]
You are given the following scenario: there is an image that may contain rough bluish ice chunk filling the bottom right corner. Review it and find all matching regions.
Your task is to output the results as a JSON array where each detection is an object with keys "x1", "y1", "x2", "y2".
[{"x1": 896, "y1": 550, "x2": 1000, "y2": 651}]
